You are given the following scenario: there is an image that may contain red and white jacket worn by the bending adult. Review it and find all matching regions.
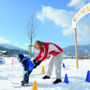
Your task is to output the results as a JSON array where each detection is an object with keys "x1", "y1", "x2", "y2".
[{"x1": 35, "y1": 42, "x2": 63, "y2": 61}]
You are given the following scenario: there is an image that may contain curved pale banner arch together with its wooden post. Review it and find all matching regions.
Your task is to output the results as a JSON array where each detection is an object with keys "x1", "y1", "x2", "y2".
[{"x1": 72, "y1": 3, "x2": 90, "y2": 68}]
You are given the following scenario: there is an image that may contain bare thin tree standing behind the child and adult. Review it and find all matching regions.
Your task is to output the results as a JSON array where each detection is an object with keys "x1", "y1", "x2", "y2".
[{"x1": 27, "y1": 16, "x2": 37, "y2": 57}]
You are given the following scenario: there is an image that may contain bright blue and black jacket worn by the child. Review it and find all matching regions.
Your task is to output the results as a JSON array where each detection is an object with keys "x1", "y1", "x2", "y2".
[{"x1": 21, "y1": 57, "x2": 34, "y2": 71}]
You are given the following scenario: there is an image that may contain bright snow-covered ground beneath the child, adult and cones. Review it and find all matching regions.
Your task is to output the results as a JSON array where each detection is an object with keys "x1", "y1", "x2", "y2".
[{"x1": 0, "y1": 57, "x2": 90, "y2": 90}]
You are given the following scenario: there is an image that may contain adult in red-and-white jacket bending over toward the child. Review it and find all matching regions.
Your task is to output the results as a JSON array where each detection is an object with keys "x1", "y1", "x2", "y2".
[{"x1": 33, "y1": 41, "x2": 63, "y2": 84}]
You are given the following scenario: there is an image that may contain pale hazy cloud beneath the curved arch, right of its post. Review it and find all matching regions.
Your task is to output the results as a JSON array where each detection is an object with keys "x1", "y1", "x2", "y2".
[{"x1": 77, "y1": 14, "x2": 90, "y2": 42}]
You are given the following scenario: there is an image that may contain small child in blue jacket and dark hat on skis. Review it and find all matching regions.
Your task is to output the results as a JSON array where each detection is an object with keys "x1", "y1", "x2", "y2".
[{"x1": 17, "y1": 54, "x2": 34, "y2": 86}]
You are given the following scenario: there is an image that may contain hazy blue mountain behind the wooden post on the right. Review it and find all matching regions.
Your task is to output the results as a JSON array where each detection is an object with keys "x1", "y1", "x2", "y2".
[{"x1": 63, "y1": 45, "x2": 90, "y2": 56}]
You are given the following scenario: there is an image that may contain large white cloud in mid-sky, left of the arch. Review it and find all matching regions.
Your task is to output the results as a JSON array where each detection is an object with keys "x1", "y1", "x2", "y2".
[{"x1": 37, "y1": 6, "x2": 75, "y2": 35}]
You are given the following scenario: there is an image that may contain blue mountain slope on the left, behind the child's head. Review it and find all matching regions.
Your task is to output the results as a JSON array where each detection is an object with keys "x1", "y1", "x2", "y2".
[{"x1": 0, "y1": 44, "x2": 28, "y2": 56}]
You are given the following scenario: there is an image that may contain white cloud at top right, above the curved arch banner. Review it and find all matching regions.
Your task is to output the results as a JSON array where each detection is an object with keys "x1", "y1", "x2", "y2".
[{"x1": 68, "y1": 0, "x2": 90, "y2": 9}]
